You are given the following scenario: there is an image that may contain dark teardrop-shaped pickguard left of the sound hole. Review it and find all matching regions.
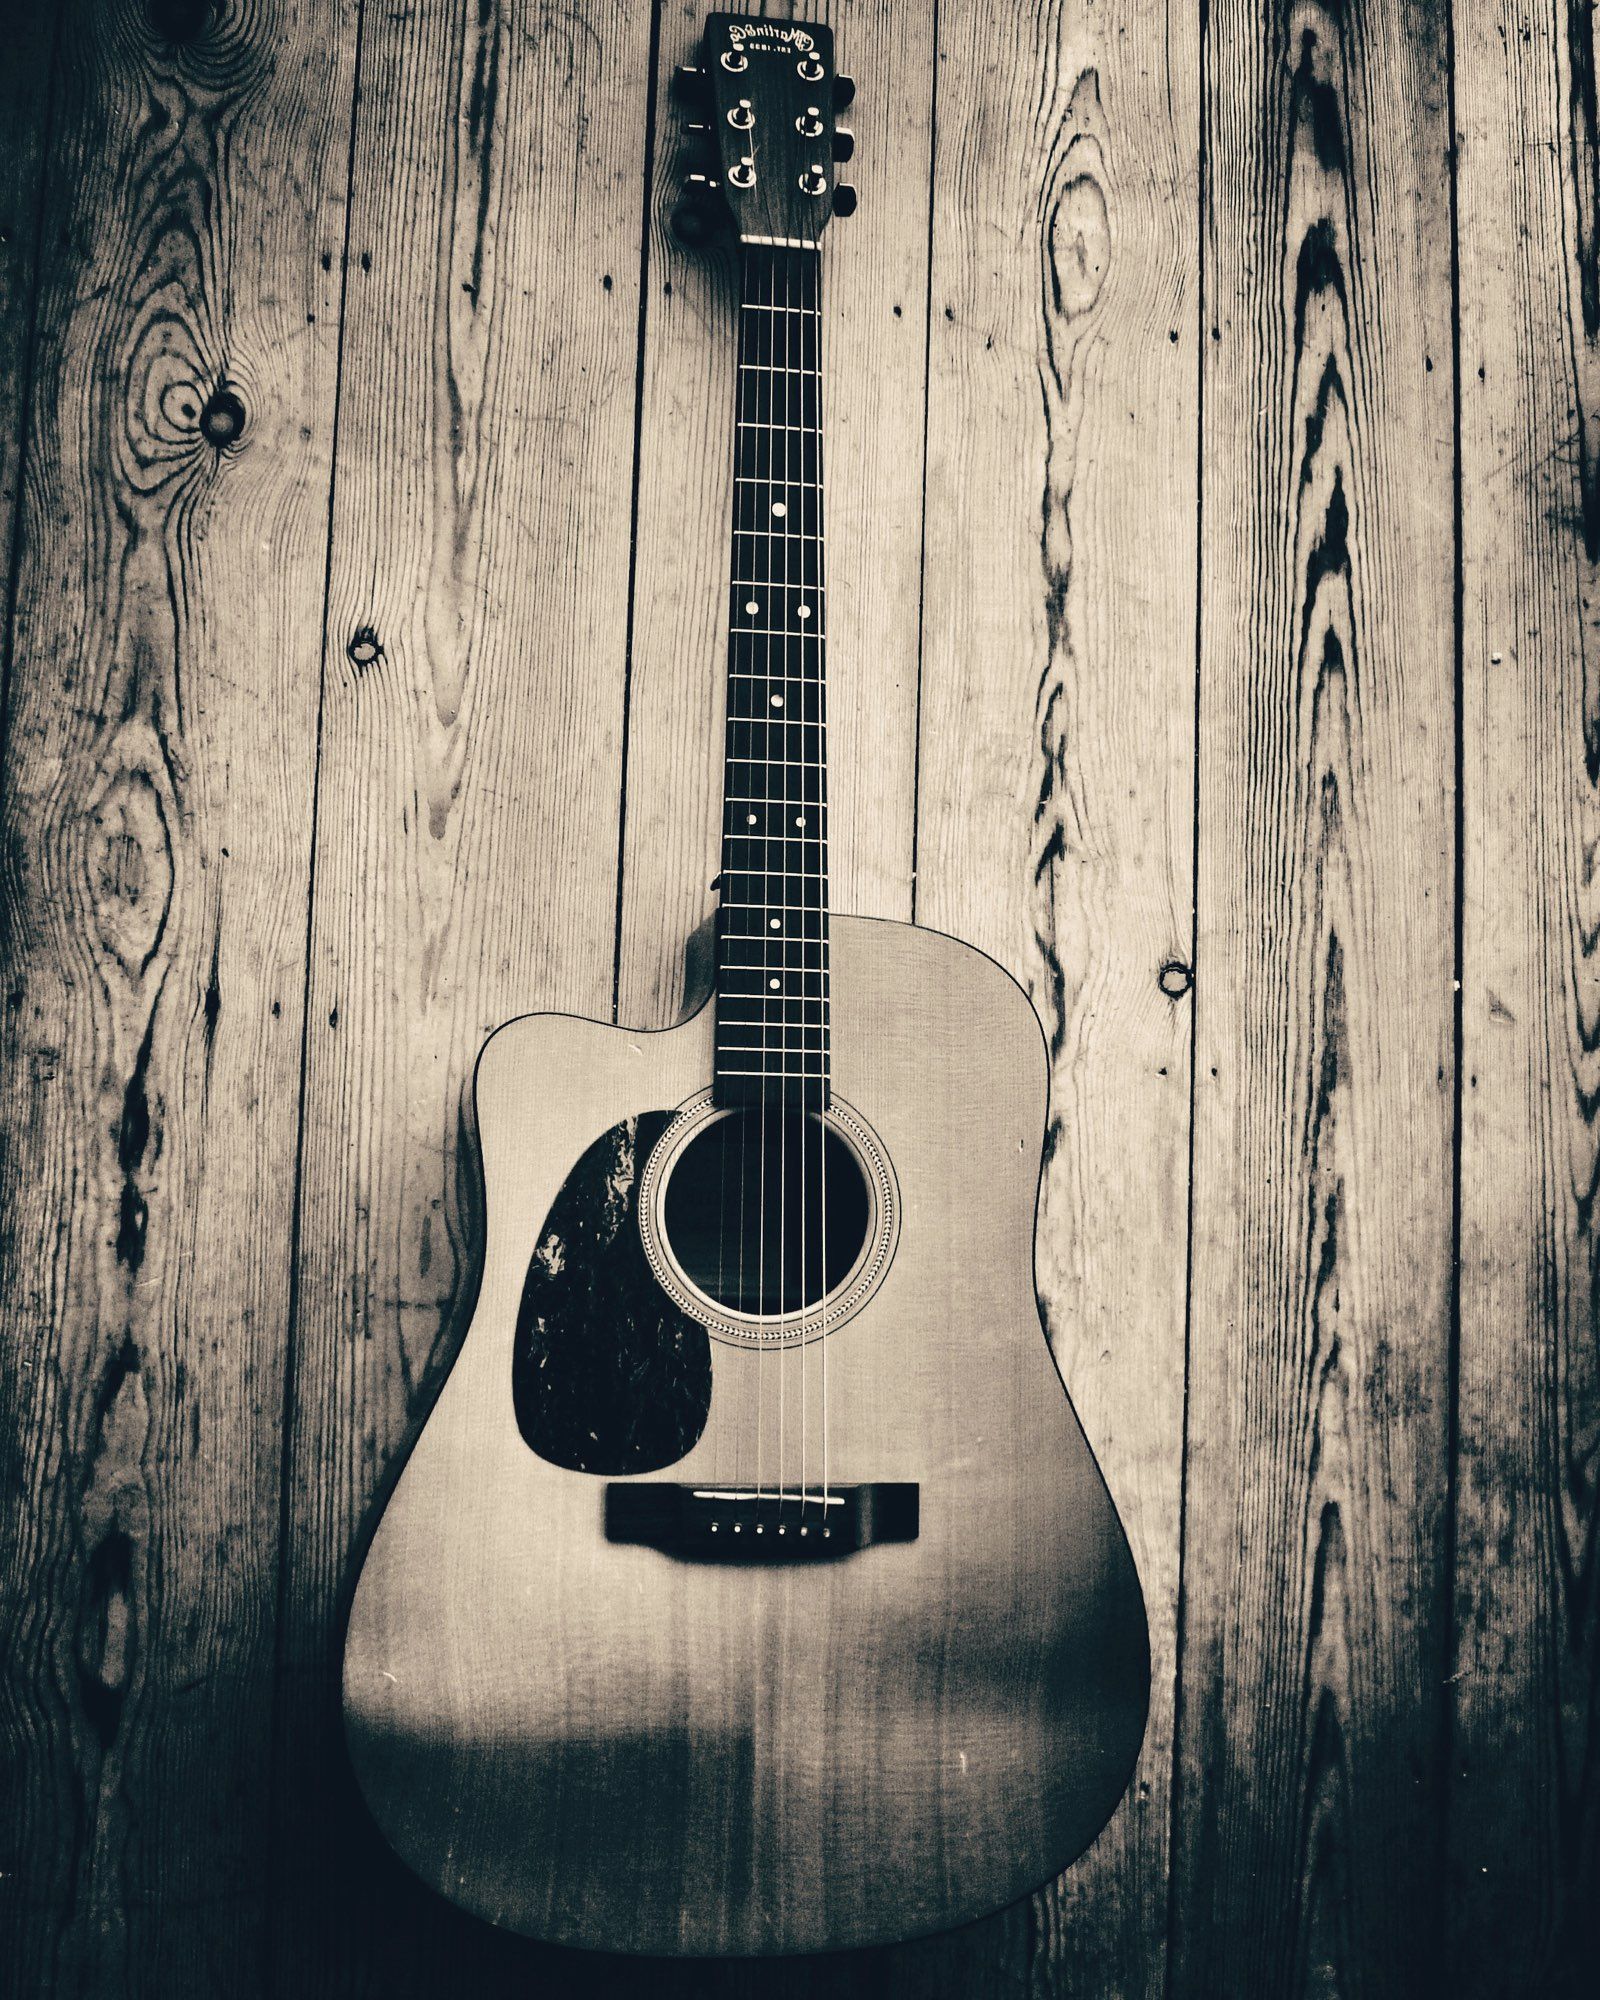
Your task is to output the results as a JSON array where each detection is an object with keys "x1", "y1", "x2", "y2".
[{"x1": 512, "y1": 1112, "x2": 712, "y2": 1474}]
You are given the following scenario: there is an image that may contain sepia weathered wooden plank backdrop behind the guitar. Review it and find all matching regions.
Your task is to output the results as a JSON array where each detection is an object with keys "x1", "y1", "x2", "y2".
[{"x1": 0, "y1": 0, "x2": 1600, "y2": 2000}]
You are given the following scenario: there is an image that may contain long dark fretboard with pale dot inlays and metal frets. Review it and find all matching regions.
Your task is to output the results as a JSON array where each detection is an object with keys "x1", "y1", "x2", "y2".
[{"x1": 716, "y1": 248, "x2": 828, "y2": 1108}]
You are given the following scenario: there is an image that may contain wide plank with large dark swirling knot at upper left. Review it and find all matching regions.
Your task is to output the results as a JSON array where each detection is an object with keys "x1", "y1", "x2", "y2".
[{"x1": 0, "y1": 0, "x2": 350, "y2": 1996}]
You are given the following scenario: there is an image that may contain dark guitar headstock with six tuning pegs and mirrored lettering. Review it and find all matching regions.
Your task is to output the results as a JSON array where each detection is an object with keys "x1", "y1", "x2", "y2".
[{"x1": 672, "y1": 14, "x2": 856, "y2": 246}]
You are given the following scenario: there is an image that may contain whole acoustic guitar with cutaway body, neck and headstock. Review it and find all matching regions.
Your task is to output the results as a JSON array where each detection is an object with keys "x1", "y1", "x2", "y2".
[{"x1": 344, "y1": 14, "x2": 1150, "y2": 1954}]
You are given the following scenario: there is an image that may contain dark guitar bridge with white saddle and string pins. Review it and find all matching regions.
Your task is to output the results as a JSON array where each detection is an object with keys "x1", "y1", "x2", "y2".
[{"x1": 606, "y1": 1480, "x2": 918, "y2": 1562}]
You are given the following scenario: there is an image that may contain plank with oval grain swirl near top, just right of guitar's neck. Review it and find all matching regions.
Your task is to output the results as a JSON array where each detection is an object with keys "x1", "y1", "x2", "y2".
[{"x1": 916, "y1": 4, "x2": 1198, "y2": 1996}]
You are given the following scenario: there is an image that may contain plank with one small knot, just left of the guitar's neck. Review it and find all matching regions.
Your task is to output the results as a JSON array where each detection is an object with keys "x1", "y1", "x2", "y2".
[{"x1": 274, "y1": 0, "x2": 650, "y2": 1992}]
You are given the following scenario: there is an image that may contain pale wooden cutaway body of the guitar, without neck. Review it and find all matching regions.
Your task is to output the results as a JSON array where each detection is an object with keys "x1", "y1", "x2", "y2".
[{"x1": 344, "y1": 918, "x2": 1148, "y2": 1954}]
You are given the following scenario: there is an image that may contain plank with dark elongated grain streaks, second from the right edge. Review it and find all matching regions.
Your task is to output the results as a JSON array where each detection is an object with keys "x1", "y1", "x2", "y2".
[{"x1": 1174, "y1": 0, "x2": 1454, "y2": 2000}]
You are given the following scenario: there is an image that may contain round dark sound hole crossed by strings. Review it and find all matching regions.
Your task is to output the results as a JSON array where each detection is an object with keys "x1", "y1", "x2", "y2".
[{"x1": 660, "y1": 1106, "x2": 872, "y2": 1318}]
